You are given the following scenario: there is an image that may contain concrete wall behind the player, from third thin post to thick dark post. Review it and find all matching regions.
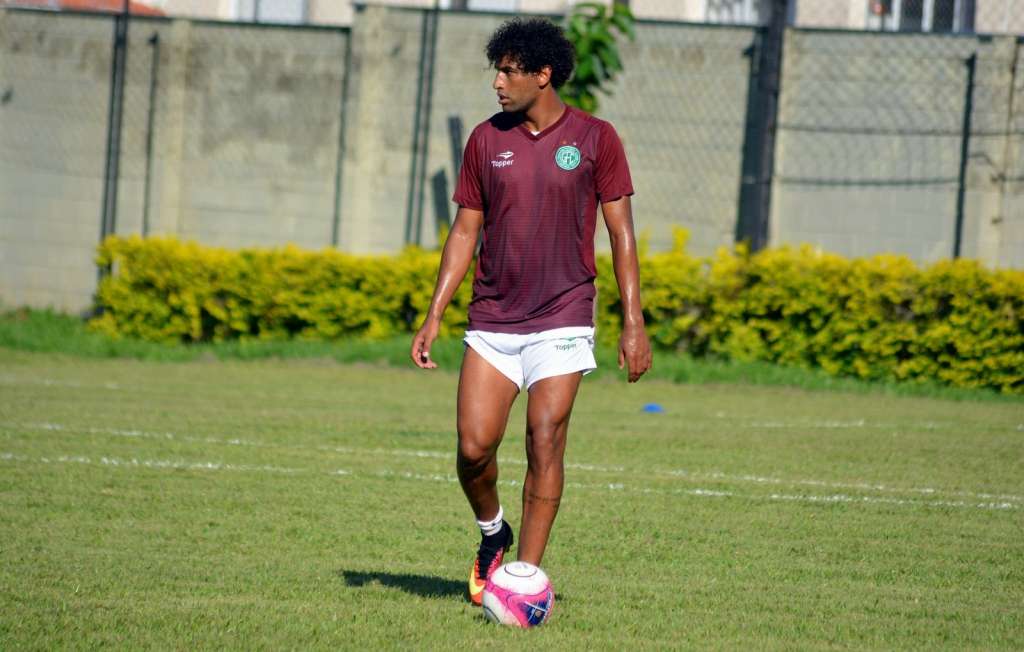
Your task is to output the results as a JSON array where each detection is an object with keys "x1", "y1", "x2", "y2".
[{"x1": 352, "y1": 7, "x2": 754, "y2": 254}]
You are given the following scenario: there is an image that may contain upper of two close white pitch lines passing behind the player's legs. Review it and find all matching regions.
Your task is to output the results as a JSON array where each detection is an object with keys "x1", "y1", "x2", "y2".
[{"x1": 0, "y1": 423, "x2": 1024, "y2": 503}]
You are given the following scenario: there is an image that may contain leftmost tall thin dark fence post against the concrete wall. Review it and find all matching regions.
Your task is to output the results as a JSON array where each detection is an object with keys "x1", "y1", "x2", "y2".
[{"x1": 99, "y1": 0, "x2": 130, "y2": 268}]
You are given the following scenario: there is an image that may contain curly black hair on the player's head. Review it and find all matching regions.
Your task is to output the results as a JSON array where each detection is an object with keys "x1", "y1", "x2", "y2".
[{"x1": 485, "y1": 18, "x2": 575, "y2": 88}]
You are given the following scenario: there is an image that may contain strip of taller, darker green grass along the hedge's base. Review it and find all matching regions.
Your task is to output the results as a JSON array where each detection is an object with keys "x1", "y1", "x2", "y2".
[{"x1": 0, "y1": 309, "x2": 1024, "y2": 404}]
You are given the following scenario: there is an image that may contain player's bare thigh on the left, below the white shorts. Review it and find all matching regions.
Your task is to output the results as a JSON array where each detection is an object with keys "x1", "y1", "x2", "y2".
[{"x1": 458, "y1": 346, "x2": 519, "y2": 448}]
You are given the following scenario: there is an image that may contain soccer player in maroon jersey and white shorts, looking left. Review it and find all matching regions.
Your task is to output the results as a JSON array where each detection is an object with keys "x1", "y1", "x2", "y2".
[{"x1": 410, "y1": 18, "x2": 651, "y2": 604}]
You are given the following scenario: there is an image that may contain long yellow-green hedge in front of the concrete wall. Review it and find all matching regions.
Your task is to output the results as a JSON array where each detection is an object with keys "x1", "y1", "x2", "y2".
[{"x1": 93, "y1": 233, "x2": 1024, "y2": 392}]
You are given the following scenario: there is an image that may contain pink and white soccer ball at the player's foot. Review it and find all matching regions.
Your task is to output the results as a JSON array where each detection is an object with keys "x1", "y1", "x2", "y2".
[{"x1": 483, "y1": 562, "x2": 555, "y2": 627}]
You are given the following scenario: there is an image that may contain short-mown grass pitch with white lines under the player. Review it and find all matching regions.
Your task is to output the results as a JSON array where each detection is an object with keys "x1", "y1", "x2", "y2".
[{"x1": 0, "y1": 348, "x2": 1024, "y2": 650}]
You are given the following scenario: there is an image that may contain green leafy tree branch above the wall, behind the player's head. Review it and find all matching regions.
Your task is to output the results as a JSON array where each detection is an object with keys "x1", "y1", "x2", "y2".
[{"x1": 560, "y1": 0, "x2": 636, "y2": 113}]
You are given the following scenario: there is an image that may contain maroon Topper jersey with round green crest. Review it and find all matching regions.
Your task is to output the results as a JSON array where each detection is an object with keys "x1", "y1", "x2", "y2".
[{"x1": 453, "y1": 106, "x2": 633, "y2": 334}]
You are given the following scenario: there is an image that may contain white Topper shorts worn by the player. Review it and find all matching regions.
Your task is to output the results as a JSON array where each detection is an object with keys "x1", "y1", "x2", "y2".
[{"x1": 463, "y1": 327, "x2": 597, "y2": 390}]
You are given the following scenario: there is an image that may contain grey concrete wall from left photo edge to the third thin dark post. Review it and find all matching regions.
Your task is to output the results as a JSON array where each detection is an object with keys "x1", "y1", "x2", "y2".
[{"x1": 0, "y1": 11, "x2": 348, "y2": 311}]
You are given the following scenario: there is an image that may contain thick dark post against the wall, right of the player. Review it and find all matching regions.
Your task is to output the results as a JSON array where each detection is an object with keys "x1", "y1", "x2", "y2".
[{"x1": 735, "y1": 0, "x2": 790, "y2": 251}]
